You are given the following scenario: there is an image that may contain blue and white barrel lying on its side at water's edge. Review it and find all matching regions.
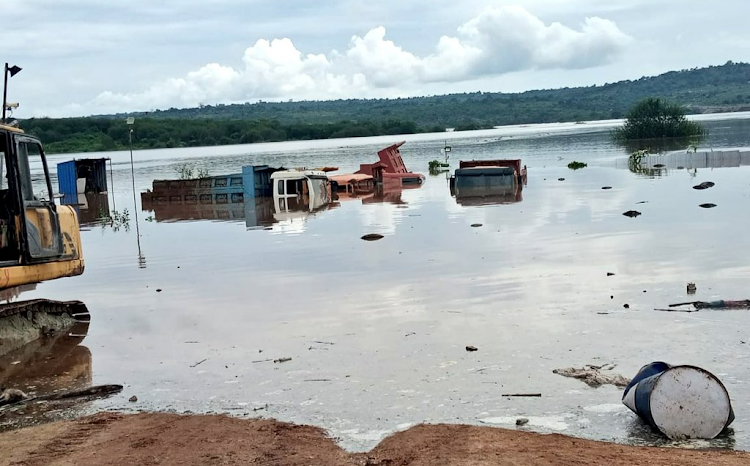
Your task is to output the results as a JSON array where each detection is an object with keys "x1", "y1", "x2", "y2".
[{"x1": 622, "y1": 362, "x2": 734, "y2": 440}]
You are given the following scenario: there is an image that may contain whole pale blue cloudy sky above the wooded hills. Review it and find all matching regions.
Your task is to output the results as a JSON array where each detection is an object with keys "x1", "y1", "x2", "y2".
[{"x1": 0, "y1": 0, "x2": 750, "y2": 118}]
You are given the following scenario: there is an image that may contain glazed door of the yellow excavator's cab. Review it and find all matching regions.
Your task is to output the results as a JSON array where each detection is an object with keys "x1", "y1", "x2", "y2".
[{"x1": 16, "y1": 137, "x2": 63, "y2": 262}]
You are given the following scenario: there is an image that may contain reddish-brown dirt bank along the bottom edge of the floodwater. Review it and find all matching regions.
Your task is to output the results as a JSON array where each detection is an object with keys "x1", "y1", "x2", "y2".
[{"x1": 0, "y1": 413, "x2": 750, "y2": 466}]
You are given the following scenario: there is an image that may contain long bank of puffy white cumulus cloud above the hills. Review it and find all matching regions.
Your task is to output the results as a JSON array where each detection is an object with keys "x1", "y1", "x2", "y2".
[{"x1": 67, "y1": 6, "x2": 631, "y2": 112}]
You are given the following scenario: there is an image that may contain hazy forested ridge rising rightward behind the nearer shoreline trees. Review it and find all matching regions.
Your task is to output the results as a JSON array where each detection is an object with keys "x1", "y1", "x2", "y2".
[{"x1": 109, "y1": 62, "x2": 750, "y2": 128}]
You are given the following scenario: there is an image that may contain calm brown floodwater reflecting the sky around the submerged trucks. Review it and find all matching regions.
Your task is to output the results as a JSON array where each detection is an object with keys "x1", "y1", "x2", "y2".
[{"x1": 0, "y1": 114, "x2": 750, "y2": 450}]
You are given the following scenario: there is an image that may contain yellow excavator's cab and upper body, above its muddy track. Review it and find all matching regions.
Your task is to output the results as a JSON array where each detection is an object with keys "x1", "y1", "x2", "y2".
[{"x1": 0, "y1": 125, "x2": 84, "y2": 289}]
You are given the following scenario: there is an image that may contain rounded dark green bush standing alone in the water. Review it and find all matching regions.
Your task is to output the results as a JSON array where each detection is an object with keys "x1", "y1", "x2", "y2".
[{"x1": 614, "y1": 97, "x2": 706, "y2": 141}]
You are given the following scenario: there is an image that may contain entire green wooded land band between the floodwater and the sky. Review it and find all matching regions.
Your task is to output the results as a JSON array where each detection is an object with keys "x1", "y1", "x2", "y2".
[{"x1": 22, "y1": 62, "x2": 750, "y2": 153}]
